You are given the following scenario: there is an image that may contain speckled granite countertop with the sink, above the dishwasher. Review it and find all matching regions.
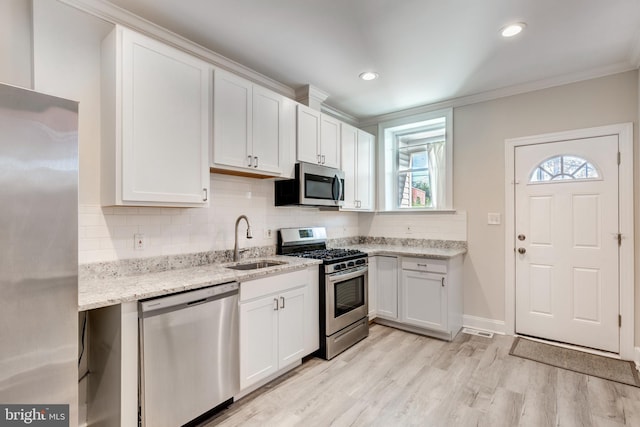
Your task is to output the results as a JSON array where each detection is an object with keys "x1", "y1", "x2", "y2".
[{"x1": 78, "y1": 255, "x2": 321, "y2": 311}]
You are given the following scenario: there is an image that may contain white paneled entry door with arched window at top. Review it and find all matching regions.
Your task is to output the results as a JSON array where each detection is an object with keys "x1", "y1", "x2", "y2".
[{"x1": 514, "y1": 135, "x2": 619, "y2": 353}]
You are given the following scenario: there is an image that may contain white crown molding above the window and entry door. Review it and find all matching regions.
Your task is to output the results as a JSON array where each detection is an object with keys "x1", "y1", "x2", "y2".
[{"x1": 358, "y1": 61, "x2": 640, "y2": 127}]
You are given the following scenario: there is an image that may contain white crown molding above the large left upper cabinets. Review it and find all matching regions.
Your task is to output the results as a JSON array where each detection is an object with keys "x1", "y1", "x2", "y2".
[{"x1": 59, "y1": 0, "x2": 295, "y2": 98}]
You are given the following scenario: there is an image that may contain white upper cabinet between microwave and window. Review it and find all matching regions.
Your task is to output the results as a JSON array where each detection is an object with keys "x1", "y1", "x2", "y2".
[{"x1": 341, "y1": 123, "x2": 375, "y2": 211}]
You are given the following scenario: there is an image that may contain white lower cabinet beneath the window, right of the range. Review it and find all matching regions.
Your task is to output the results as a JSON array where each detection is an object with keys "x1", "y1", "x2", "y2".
[{"x1": 375, "y1": 256, "x2": 463, "y2": 340}]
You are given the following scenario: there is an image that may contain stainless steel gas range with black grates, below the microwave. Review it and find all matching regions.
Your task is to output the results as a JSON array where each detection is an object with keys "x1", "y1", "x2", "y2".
[{"x1": 277, "y1": 227, "x2": 369, "y2": 360}]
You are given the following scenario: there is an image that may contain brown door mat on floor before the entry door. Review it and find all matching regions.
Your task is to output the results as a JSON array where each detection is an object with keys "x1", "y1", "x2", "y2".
[{"x1": 509, "y1": 337, "x2": 640, "y2": 387}]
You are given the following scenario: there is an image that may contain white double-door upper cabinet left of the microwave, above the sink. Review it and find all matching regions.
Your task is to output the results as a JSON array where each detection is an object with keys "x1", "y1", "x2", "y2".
[{"x1": 211, "y1": 69, "x2": 284, "y2": 176}]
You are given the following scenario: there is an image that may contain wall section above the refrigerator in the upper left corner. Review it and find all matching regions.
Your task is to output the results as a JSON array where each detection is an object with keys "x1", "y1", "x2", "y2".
[{"x1": 0, "y1": 0, "x2": 32, "y2": 89}]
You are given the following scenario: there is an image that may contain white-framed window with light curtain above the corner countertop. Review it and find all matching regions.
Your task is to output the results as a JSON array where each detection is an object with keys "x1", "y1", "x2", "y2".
[{"x1": 379, "y1": 109, "x2": 453, "y2": 211}]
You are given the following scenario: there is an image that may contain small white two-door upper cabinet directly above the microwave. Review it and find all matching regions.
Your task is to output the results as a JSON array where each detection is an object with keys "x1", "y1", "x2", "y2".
[{"x1": 297, "y1": 104, "x2": 340, "y2": 168}]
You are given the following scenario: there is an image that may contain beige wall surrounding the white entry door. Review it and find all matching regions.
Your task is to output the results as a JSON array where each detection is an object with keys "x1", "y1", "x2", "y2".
[{"x1": 453, "y1": 71, "x2": 640, "y2": 333}]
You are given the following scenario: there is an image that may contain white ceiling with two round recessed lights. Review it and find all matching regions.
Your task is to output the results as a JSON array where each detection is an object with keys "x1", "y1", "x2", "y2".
[{"x1": 104, "y1": 0, "x2": 640, "y2": 119}]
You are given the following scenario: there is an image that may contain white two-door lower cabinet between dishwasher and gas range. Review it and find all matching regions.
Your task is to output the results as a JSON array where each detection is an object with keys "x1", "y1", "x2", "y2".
[{"x1": 240, "y1": 267, "x2": 319, "y2": 391}]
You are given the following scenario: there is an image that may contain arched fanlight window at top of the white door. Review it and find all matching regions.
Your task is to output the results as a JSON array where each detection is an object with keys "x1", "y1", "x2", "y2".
[{"x1": 529, "y1": 154, "x2": 600, "y2": 183}]
